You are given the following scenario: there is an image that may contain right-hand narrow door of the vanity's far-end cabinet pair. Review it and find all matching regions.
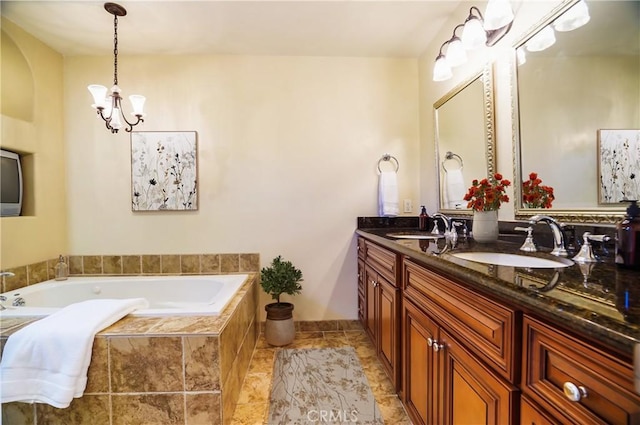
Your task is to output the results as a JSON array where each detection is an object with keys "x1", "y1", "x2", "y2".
[{"x1": 378, "y1": 276, "x2": 400, "y2": 390}]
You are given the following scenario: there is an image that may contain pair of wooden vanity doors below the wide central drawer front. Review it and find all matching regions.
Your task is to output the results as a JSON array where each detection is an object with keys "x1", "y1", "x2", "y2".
[{"x1": 402, "y1": 280, "x2": 517, "y2": 424}]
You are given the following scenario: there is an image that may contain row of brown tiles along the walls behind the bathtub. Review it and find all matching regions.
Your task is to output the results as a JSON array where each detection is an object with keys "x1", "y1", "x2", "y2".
[{"x1": 0, "y1": 253, "x2": 260, "y2": 292}]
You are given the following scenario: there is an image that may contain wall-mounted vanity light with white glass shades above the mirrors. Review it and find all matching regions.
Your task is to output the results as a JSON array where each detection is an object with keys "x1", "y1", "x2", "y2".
[{"x1": 433, "y1": 0, "x2": 513, "y2": 81}]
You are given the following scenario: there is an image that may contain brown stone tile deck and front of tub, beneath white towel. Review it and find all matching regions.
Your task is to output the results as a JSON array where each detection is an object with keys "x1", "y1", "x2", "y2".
[{"x1": 0, "y1": 273, "x2": 259, "y2": 425}]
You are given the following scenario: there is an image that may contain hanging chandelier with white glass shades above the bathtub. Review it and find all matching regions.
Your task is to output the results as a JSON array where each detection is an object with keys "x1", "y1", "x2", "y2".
[{"x1": 87, "y1": 3, "x2": 146, "y2": 133}]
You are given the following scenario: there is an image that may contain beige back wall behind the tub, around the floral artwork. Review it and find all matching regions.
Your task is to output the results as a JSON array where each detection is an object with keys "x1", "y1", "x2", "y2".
[{"x1": 64, "y1": 56, "x2": 419, "y2": 320}]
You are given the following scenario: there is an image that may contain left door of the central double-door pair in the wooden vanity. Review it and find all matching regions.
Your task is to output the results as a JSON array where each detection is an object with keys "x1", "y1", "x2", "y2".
[{"x1": 402, "y1": 298, "x2": 438, "y2": 425}]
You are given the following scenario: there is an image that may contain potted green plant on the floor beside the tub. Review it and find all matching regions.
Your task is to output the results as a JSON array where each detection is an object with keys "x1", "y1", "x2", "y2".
[{"x1": 260, "y1": 255, "x2": 302, "y2": 346}]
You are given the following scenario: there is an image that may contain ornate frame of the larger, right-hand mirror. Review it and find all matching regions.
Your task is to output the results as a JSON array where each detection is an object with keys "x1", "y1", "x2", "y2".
[{"x1": 510, "y1": 0, "x2": 625, "y2": 224}]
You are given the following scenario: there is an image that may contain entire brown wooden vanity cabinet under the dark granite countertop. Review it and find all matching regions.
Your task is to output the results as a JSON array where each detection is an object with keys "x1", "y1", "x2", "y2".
[{"x1": 358, "y1": 232, "x2": 640, "y2": 425}]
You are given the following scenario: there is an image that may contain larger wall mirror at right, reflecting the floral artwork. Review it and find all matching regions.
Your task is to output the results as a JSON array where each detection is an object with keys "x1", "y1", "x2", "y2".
[{"x1": 514, "y1": 0, "x2": 640, "y2": 223}]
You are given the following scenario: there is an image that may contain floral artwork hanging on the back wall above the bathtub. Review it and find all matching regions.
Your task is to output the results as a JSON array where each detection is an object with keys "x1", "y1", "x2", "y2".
[{"x1": 131, "y1": 131, "x2": 198, "y2": 211}]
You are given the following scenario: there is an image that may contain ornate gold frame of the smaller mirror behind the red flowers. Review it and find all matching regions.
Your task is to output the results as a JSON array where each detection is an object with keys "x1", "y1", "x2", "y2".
[{"x1": 433, "y1": 63, "x2": 496, "y2": 217}]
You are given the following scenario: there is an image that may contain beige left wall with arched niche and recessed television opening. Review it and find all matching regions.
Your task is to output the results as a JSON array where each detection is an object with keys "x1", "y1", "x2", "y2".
[{"x1": 0, "y1": 19, "x2": 68, "y2": 269}]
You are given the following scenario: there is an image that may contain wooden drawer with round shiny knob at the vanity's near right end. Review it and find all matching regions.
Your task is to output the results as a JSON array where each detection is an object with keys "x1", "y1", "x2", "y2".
[{"x1": 522, "y1": 316, "x2": 640, "y2": 424}]
